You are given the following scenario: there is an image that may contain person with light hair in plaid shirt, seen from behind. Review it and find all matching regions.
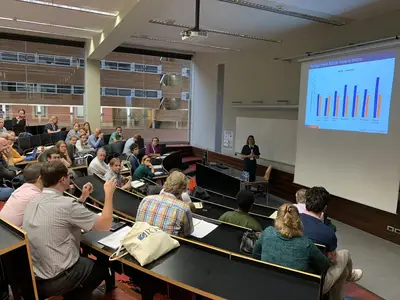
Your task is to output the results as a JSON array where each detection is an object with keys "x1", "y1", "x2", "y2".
[{"x1": 136, "y1": 171, "x2": 194, "y2": 236}]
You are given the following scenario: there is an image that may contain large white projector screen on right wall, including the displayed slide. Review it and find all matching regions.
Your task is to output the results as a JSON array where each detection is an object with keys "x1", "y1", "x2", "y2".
[{"x1": 294, "y1": 49, "x2": 400, "y2": 213}]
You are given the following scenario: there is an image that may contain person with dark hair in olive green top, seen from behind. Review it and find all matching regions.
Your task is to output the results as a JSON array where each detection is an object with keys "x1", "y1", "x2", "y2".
[{"x1": 219, "y1": 190, "x2": 263, "y2": 231}]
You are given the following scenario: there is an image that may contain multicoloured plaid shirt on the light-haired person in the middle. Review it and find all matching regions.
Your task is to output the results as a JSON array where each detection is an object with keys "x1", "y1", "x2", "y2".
[{"x1": 136, "y1": 192, "x2": 194, "y2": 236}]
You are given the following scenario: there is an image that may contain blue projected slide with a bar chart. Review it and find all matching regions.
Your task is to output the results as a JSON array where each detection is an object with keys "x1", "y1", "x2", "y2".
[{"x1": 305, "y1": 51, "x2": 396, "y2": 134}]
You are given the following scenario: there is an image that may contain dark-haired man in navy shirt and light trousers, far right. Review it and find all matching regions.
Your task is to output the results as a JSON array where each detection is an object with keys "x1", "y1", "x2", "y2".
[{"x1": 300, "y1": 187, "x2": 363, "y2": 299}]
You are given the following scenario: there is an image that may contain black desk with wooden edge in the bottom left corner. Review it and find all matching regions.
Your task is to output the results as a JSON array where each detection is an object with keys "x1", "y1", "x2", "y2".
[{"x1": 0, "y1": 218, "x2": 38, "y2": 300}]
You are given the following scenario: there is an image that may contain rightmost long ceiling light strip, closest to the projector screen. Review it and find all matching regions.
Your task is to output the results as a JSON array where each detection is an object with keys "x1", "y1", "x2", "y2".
[{"x1": 218, "y1": 0, "x2": 346, "y2": 26}]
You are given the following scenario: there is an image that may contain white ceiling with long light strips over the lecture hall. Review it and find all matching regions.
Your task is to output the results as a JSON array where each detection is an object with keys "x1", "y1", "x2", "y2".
[{"x1": 0, "y1": 0, "x2": 400, "y2": 52}]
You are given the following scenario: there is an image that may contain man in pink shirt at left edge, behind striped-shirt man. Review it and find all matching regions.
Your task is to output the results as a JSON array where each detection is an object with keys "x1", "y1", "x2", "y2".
[{"x1": 0, "y1": 163, "x2": 43, "y2": 227}]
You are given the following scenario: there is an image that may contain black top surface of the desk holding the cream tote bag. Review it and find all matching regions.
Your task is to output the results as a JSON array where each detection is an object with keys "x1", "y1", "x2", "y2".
[{"x1": 83, "y1": 232, "x2": 319, "y2": 300}]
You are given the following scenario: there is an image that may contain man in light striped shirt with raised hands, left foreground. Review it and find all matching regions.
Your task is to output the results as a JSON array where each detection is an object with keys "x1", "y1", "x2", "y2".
[{"x1": 22, "y1": 161, "x2": 115, "y2": 300}]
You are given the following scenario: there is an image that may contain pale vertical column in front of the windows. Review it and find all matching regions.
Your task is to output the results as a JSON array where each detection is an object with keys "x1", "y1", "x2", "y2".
[{"x1": 83, "y1": 59, "x2": 101, "y2": 131}]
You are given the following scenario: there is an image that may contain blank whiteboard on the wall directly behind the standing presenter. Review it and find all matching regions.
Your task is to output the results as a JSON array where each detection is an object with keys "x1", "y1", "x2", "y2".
[{"x1": 235, "y1": 117, "x2": 297, "y2": 165}]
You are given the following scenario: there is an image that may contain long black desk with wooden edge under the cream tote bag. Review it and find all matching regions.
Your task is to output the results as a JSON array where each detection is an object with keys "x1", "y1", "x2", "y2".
[{"x1": 81, "y1": 232, "x2": 321, "y2": 300}]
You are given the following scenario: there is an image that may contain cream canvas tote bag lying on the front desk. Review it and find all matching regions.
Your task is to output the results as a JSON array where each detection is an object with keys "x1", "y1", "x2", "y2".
[{"x1": 109, "y1": 222, "x2": 179, "y2": 266}]
